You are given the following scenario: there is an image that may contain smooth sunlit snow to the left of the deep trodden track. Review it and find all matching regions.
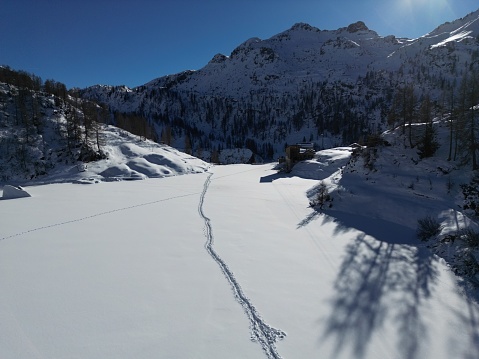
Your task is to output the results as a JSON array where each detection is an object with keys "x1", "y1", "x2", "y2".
[{"x1": 0, "y1": 175, "x2": 262, "y2": 358}]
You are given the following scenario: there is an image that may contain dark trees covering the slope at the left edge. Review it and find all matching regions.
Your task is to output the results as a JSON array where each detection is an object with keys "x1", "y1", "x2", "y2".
[{"x1": 0, "y1": 67, "x2": 110, "y2": 181}]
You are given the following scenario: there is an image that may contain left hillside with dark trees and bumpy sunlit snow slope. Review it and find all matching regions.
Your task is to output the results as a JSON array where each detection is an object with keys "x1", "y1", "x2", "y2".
[{"x1": 0, "y1": 72, "x2": 210, "y2": 184}]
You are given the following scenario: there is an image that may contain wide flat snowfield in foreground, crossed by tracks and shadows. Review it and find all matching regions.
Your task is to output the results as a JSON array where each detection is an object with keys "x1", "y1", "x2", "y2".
[{"x1": 0, "y1": 148, "x2": 479, "y2": 359}]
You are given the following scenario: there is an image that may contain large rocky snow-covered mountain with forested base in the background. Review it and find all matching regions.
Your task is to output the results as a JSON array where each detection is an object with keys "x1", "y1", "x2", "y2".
[{"x1": 82, "y1": 10, "x2": 479, "y2": 158}]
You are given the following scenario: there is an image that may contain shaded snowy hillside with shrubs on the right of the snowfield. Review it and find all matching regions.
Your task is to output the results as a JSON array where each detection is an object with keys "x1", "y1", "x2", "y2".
[{"x1": 291, "y1": 118, "x2": 479, "y2": 292}]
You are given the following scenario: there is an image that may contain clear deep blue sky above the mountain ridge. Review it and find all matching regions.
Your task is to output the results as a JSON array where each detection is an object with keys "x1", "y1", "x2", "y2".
[{"x1": 0, "y1": 0, "x2": 479, "y2": 88}]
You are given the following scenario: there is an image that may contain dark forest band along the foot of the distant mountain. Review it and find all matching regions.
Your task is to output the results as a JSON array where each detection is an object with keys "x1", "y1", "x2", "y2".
[{"x1": 134, "y1": 82, "x2": 387, "y2": 159}]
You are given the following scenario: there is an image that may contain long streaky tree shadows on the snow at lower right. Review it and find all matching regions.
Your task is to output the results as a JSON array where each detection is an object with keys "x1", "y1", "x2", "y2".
[{"x1": 321, "y1": 212, "x2": 437, "y2": 359}]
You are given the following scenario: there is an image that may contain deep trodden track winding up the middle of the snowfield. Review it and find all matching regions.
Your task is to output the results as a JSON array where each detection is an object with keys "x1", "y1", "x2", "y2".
[{"x1": 198, "y1": 173, "x2": 286, "y2": 359}]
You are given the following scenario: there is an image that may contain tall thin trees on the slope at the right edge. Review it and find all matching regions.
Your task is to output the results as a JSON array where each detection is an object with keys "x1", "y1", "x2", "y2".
[{"x1": 388, "y1": 64, "x2": 479, "y2": 170}]
